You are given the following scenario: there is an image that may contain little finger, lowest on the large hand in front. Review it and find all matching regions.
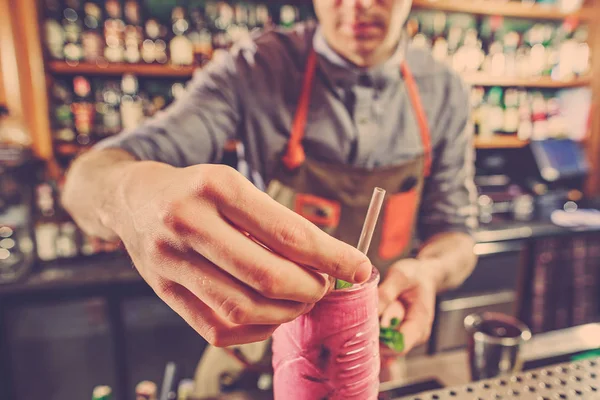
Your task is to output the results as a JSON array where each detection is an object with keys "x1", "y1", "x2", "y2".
[{"x1": 153, "y1": 282, "x2": 277, "y2": 347}]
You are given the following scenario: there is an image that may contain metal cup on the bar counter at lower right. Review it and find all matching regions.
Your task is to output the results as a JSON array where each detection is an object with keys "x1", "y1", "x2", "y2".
[{"x1": 464, "y1": 312, "x2": 531, "y2": 381}]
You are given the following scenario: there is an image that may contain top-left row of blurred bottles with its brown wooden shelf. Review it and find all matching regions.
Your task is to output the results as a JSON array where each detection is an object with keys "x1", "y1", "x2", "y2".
[{"x1": 43, "y1": 0, "x2": 313, "y2": 70}]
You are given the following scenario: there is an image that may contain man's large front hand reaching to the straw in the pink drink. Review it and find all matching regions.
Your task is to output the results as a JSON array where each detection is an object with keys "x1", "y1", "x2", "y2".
[{"x1": 101, "y1": 162, "x2": 372, "y2": 346}]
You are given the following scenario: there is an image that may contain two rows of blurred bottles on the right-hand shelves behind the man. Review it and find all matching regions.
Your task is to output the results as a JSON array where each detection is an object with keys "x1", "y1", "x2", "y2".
[{"x1": 408, "y1": 9, "x2": 590, "y2": 148}]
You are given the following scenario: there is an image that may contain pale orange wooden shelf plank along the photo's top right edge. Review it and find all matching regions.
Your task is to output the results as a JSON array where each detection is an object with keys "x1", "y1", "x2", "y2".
[{"x1": 413, "y1": 0, "x2": 593, "y2": 20}]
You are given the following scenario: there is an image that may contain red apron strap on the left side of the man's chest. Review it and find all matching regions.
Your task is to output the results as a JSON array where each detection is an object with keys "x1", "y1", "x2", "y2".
[{"x1": 282, "y1": 50, "x2": 317, "y2": 169}]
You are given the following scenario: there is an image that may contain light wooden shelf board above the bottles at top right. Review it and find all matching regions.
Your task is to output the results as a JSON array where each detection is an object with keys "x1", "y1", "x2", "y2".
[{"x1": 413, "y1": 0, "x2": 595, "y2": 20}]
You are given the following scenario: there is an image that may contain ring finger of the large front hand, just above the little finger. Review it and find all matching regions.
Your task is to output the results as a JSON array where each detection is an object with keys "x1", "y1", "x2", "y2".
[{"x1": 159, "y1": 250, "x2": 309, "y2": 325}]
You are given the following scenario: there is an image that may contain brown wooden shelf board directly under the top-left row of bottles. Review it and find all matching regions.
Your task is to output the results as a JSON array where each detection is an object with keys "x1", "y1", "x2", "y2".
[{"x1": 48, "y1": 61, "x2": 198, "y2": 78}]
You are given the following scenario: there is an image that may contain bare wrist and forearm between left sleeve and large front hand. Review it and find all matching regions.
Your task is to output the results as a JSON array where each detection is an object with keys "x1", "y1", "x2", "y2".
[{"x1": 62, "y1": 149, "x2": 137, "y2": 240}]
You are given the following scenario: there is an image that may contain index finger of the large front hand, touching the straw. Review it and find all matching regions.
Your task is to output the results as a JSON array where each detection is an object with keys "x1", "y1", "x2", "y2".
[{"x1": 217, "y1": 175, "x2": 372, "y2": 283}]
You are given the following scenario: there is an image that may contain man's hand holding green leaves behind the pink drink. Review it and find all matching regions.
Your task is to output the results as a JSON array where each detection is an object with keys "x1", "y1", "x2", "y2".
[{"x1": 379, "y1": 259, "x2": 436, "y2": 364}]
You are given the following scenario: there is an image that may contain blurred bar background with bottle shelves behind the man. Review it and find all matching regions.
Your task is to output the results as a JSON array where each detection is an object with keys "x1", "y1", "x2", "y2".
[{"x1": 0, "y1": 0, "x2": 600, "y2": 400}]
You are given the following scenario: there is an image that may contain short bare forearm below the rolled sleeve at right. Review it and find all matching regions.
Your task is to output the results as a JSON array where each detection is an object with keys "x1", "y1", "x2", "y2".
[{"x1": 417, "y1": 232, "x2": 477, "y2": 292}]
